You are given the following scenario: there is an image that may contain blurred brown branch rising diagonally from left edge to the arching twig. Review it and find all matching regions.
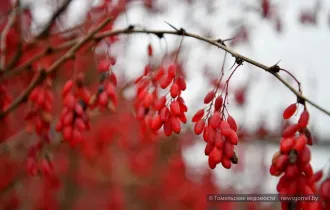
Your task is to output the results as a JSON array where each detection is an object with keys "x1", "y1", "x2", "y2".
[{"x1": 0, "y1": 18, "x2": 111, "y2": 119}]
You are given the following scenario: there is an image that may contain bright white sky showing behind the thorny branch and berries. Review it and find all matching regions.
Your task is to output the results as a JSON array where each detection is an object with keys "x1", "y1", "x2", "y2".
[{"x1": 22, "y1": 0, "x2": 330, "y2": 192}]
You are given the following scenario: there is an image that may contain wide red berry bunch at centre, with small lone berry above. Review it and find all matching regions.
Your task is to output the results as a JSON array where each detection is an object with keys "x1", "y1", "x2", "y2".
[{"x1": 135, "y1": 43, "x2": 188, "y2": 136}]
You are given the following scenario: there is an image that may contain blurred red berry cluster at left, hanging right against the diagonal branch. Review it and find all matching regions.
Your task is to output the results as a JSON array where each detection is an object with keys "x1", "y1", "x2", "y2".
[{"x1": 25, "y1": 79, "x2": 54, "y2": 142}]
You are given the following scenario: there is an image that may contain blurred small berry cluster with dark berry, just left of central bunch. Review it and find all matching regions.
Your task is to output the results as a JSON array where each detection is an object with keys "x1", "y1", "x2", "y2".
[{"x1": 89, "y1": 59, "x2": 118, "y2": 111}]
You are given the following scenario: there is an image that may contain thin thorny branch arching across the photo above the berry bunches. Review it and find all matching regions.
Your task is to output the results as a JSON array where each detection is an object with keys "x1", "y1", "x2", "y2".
[{"x1": 0, "y1": 27, "x2": 330, "y2": 116}]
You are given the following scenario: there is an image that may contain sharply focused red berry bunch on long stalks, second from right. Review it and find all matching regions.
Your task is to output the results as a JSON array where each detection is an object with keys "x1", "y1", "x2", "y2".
[{"x1": 192, "y1": 90, "x2": 238, "y2": 169}]
